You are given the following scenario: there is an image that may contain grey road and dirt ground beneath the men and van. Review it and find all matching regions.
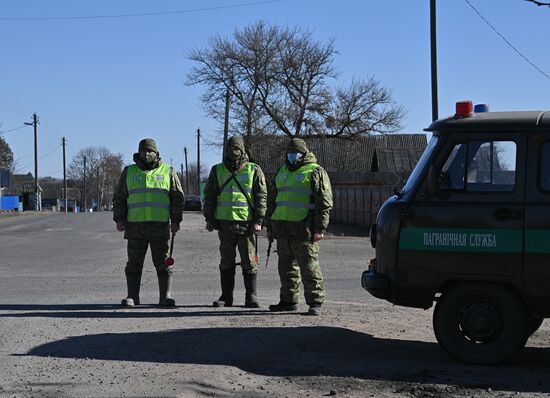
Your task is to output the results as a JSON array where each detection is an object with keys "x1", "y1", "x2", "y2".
[{"x1": 0, "y1": 214, "x2": 550, "y2": 397}]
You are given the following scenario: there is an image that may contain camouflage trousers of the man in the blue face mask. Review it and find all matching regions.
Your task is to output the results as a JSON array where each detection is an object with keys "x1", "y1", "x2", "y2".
[{"x1": 277, "y1": 237, "x2": 325, "y2": 305}]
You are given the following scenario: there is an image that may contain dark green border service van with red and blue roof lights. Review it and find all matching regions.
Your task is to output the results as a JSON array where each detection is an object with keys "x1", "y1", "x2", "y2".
[{"x1": 361, "y1": 101, "x2": 550, "y2": 364}]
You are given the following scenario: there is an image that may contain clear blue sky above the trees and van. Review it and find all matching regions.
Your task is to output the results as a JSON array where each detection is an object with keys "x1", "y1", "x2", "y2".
[{"x1": 0, "y1": 0, "x2": 550, "y2": 177}]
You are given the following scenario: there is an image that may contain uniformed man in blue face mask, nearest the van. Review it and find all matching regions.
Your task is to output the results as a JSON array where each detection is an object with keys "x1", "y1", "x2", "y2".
[{"x1": 266, "y1": 138, "x2": 332, "y2": 315}]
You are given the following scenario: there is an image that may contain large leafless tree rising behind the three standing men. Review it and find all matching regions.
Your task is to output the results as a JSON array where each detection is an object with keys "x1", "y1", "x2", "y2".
[{"x1": 187, "y1": 21, "x2": 405, "y2": 139}]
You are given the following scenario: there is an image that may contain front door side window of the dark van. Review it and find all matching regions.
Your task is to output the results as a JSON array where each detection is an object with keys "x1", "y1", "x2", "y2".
[{"x1": 440, "y1": 141, "x2": 516, "y2": 192}]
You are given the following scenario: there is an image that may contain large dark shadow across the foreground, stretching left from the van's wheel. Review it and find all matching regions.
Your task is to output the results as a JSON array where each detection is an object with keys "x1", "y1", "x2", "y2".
[{"x1": 26, "y1": 327, "x2": 550, "y2": 393}]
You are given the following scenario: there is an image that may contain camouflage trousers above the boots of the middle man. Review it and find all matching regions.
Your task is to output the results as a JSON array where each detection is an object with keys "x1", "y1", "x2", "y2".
[{"x1": 218, "y1": 222, "x2": 258, "y2": 274}]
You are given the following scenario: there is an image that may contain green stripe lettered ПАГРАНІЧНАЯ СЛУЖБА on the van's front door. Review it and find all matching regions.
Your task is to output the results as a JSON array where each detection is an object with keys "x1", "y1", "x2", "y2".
[{"x1": 399, "y1": 228, "x2": 522, "y2": 253}]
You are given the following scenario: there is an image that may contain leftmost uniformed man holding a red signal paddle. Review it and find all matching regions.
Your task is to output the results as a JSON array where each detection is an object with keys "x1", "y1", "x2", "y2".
[{"x1": 113, "y1": 138, "x2": 184, "y2": 307}]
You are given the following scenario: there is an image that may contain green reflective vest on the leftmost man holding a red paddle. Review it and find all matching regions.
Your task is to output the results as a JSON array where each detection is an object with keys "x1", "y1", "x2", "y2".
[{"x1": 126, "y1": 163, "x2": 170, "y2": 222}]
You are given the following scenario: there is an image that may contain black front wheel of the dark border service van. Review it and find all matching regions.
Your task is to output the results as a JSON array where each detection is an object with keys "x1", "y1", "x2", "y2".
[{"x1": 433, "y1": 283, "x2": 529, "y2": 365}]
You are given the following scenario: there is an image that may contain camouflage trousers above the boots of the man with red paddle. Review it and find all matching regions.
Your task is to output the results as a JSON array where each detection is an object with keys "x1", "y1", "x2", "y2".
[{"x1": 124, "y1": 239, "x2": 173, "y2": 275}]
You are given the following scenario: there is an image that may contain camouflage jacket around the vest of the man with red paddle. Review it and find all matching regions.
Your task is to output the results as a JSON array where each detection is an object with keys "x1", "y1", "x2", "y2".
[{"x1": 113, "y1": 153, "x2": 184, "y2": 239}]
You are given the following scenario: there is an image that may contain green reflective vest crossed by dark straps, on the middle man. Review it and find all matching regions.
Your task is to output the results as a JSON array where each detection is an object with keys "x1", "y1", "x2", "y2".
[{"x1": 214, "y1": 162, "x2": 256, "y2": 221}]
